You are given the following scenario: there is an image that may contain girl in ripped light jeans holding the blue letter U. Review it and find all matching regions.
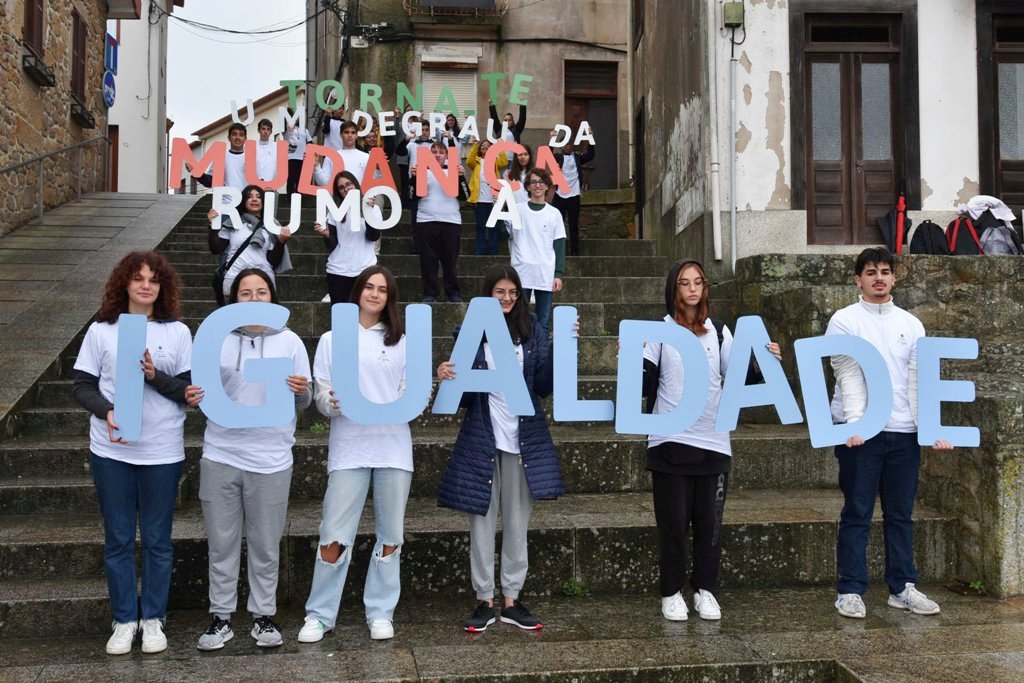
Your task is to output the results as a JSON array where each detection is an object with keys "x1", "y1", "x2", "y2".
[{"x1": 298, "y1": 265, "x2": 413, "y2": 643}]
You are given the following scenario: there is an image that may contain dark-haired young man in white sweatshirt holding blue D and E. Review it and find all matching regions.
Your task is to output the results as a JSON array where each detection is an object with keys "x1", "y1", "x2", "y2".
[{"x1": 825, "y1": 248, "x2": 952, "y2": 618}]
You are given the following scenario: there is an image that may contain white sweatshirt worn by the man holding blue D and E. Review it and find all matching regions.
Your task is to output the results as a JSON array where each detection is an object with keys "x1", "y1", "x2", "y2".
[{"x1": 825, "y1": 297, "x2": 925, "y2": 433}]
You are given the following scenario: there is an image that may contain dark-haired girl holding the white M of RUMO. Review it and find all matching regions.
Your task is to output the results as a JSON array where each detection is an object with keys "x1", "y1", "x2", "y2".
[{"x1": 313, "y1": 171, "x2": 381, "y2": 305}]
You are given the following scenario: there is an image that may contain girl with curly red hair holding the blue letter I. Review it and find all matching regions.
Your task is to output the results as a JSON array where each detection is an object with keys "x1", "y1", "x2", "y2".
[{"x1": 74, "y1": 251, "x2": 191, "y2": 654}]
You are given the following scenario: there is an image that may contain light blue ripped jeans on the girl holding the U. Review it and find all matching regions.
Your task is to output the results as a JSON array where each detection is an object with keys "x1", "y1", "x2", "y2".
[{"x1": 306, "y1": 467, "x2": 413, "y2": 629}]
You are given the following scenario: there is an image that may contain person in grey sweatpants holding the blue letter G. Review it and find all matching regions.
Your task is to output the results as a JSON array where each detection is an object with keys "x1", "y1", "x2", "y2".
[{"x1": 186, "y1": 268, "x2": 312, "y2": 651}]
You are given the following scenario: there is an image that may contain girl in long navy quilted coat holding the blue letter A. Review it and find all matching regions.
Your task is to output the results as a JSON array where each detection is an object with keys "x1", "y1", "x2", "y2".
[{"x1": 437, "y1": 264, "x2": 565, "y2": 633}]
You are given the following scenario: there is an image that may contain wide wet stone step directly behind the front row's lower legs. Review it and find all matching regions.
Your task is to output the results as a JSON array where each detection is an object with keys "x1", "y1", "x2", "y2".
[{"x1": 0, "y1": 489, "x2": 956, "y2": 626}]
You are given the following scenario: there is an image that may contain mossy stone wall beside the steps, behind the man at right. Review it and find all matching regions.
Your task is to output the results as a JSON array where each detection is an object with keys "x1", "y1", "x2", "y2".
[{"x1": 733, "y1": 254, "x2": 1024, "y2": 596}]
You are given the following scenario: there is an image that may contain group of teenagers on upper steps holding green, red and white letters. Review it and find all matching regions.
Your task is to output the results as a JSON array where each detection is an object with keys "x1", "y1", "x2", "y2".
[{"x1": 195, "y1": 104, "x2": 594, "y2": 329}]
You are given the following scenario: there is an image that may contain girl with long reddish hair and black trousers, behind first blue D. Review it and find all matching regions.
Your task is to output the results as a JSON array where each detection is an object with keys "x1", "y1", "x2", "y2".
[{"x1": 644, "y1": 259, "x2": 782, "y2": 622}]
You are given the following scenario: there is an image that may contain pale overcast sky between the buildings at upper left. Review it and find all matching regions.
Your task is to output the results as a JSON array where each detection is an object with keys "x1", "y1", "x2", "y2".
[{"x1": 167, "y1": 0, "x2": 306, "y2": 140}]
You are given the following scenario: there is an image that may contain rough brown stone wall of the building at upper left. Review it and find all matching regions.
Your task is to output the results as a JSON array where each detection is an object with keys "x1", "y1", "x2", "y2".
[{"x1": 0, "y1": 0, "x2": 106, "y2": 234}]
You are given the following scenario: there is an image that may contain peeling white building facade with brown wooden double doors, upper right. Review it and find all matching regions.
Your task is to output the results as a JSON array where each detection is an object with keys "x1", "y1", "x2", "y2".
[{"x1": 630, "y1": 0, "x2": 1024, "y2": 279}]
